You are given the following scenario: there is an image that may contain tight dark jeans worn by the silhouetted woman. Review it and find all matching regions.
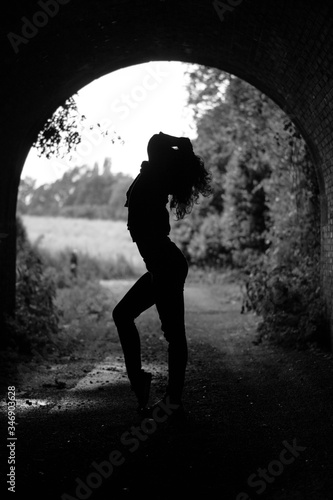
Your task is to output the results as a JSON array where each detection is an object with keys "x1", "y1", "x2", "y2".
[{"x1": 113, "y1": 237, "x2": 188, "y2": 402}]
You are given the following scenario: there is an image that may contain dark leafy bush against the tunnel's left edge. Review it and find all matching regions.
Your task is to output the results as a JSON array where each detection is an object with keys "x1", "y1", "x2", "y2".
[{"x1": 6, "y1": 218, "x2": 59, "y2": 353}]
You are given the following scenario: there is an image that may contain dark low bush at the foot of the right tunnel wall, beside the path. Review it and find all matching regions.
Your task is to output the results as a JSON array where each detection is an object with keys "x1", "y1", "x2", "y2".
[{"x1": 243, "y1": 252, "x2": 329, "y2": 348}]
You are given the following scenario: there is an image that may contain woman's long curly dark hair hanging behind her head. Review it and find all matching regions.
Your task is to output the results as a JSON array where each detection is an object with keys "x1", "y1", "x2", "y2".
[{"x1": 170, "y1": 150, "x2": 212, "y2": 220}]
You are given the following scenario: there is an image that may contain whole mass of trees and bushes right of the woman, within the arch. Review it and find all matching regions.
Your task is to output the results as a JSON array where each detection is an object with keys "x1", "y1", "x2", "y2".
[{"x1": 173, "y1": 66, "x2": 327, "y2": 346}]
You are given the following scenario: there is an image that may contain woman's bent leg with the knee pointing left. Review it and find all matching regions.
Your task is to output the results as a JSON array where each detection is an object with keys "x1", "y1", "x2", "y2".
[{"x1": 112, "y1": 272, "x2": 155, "y2": 384}]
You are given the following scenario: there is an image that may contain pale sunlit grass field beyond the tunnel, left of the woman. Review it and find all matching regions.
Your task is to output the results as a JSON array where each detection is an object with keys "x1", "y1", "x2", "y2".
[{"x1": 22, "y1": 215, "x2": 142, "y2": 268}]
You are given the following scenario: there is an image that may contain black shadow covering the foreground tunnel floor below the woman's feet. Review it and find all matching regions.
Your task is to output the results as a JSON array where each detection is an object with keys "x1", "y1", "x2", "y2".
[{"x1": 3, "y1": 340, "x2": 333, "y2": 500}]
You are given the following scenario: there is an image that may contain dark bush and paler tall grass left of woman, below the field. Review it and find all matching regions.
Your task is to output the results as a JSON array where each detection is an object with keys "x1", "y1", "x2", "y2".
[{"x1": 2, "y1": 217, "x2": 136, "y2": 357}]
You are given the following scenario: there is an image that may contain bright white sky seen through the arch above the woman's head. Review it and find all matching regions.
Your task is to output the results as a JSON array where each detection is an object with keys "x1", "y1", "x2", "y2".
[{"x1": 22, "y1": 61, "x2": 196, "y2": 184}]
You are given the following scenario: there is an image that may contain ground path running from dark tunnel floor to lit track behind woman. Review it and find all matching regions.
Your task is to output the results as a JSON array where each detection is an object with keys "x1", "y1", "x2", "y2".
[{"x1": 1, "y1": 281, "x2": 333, "y2": 500}]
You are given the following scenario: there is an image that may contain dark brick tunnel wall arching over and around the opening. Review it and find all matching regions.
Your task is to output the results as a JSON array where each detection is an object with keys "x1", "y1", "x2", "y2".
[{"x1": 0, "y1": 0, "x2": 333, "y2": 344}]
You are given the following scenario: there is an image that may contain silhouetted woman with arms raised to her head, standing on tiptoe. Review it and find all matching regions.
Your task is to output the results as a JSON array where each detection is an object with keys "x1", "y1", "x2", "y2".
[{"x1": 113, "y1": 132, "x2": 211, "y2": 411}]
